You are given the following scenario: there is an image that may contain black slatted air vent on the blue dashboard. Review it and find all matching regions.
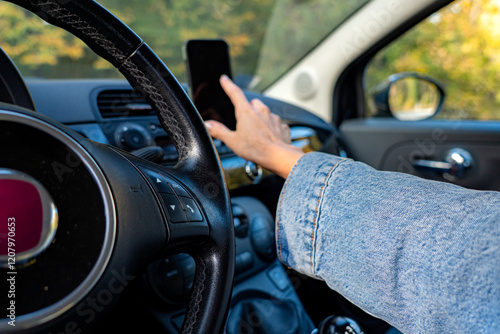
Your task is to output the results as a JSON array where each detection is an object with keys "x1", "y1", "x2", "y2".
[{"x1": 97, "y1": 89, "x2": 155, "y2": 118}]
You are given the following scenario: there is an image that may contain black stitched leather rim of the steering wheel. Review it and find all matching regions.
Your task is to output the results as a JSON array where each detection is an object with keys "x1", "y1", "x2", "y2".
[{"x1": 4, "y1": 0, "x2": 235, "y2": 333}]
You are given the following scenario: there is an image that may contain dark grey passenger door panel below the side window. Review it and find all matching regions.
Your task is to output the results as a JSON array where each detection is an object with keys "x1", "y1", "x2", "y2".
[{"x1": 340, "y1": 118, "x2": 500, "y2": 190}]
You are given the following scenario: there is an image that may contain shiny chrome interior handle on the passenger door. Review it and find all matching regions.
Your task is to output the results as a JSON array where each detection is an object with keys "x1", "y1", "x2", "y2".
[{"x1": 413, "y1": 148, "x2": 472, "y2": 179}]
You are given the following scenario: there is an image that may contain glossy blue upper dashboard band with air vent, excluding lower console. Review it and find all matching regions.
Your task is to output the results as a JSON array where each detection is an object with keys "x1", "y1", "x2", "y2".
[{"x1": 26, "y1": 79, "x2": 334, "y2": 190}]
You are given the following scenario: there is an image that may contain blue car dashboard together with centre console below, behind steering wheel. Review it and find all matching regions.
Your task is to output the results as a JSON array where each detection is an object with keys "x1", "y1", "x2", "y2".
[{"x1": 16, "y1": 79, "x2": 341, "y2": 333}]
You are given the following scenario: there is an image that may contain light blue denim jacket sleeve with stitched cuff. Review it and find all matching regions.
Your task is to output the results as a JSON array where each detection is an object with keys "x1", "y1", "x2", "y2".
[{"x1": 276, "y1": 153, "x2": 500, "y2": 333}]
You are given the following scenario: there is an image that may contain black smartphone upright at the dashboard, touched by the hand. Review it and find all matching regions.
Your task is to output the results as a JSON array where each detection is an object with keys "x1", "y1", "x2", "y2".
[{"x1": 184, "y1": 39, "x2": 236, "y2": 130}]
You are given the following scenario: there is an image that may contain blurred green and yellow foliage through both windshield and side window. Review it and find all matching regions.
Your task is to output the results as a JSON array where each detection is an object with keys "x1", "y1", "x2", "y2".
[{"x1": 0, "y1": 0, "x2": 500, "y2": 120}]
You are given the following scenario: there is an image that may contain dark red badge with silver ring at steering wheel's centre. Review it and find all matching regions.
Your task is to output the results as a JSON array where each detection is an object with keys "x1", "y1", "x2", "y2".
[{"x1": 0, "y1": 168, "x2": 58, "y2": 271}]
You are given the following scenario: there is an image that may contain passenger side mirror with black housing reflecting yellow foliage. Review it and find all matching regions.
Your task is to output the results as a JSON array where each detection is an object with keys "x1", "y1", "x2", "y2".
[{"x1": 372, "y1": 72, "x2": 445, "y2": 121}]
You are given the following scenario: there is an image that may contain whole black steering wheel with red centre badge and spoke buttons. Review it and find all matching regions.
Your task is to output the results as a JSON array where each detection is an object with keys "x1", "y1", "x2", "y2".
[{"x1": 0, "y1": 0, "x2": 235, "y2": 333}]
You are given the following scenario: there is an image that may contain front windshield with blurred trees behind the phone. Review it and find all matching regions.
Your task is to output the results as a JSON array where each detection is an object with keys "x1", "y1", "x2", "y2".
[{"x1": 0, "y1": 0, "x2": 368, "y2": 91}]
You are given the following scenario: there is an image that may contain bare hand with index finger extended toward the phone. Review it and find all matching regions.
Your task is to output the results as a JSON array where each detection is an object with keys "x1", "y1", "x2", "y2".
[{"x1": 205, "y1": 76, "x2": 304, "y2": 178}]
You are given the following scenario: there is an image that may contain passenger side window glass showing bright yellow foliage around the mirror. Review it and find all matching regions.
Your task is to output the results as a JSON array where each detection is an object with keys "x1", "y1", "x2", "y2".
[{"x1": 364, "y1": 0, "x2": 500, "y2": 120}]
